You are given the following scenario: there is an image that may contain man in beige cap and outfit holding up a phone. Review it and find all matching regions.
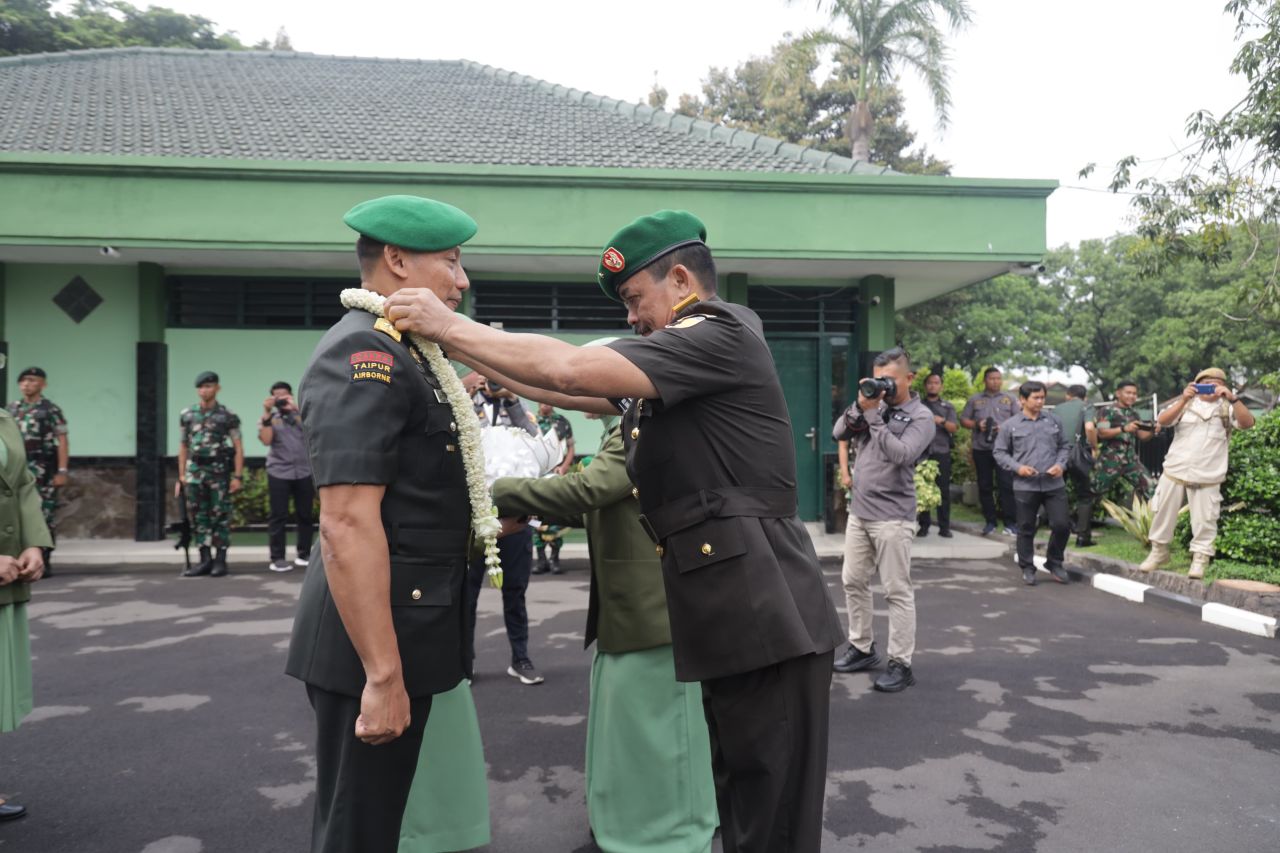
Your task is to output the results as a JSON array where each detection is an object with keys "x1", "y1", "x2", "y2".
[{"x1": 1138, "y1": 368, "x2": 1253, "y2": 578}]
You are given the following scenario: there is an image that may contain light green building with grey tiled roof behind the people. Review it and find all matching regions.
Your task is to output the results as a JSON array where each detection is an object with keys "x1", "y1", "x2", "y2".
[{"x1": 0, "y1": 49, "x2": 1056, "y2": 539}]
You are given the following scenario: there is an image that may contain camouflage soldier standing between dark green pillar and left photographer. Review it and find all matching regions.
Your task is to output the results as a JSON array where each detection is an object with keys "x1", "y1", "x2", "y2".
[{"x1": 174, "y1": 370, "x2": 244, "y2": 578}]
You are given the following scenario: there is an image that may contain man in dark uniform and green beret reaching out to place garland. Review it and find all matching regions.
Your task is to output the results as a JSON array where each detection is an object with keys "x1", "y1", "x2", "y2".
[{"x1": 387, "y1": 210, "x2": 844, "y2": 853}]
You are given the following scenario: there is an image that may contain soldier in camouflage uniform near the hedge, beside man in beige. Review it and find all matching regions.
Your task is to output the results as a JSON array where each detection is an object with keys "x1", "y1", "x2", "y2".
[{"x1": 1079, "y1": 380, "x2": 1155, "y2": 519}]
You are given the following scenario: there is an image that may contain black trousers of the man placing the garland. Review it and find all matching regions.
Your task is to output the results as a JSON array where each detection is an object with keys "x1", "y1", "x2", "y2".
[{"x1": 703, "y1": 652, "x2": 835, "y2": 853}]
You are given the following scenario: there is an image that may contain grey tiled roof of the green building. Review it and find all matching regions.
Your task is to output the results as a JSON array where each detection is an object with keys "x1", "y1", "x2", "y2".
[{"x1": 0, "y1": 47, "x2": 886, "y2": 174}]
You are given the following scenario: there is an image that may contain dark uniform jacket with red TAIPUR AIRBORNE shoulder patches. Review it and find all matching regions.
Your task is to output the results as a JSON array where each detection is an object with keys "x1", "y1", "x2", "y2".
[{"x1": 285, "y1": 310, "x2": 471, "y2": 697}]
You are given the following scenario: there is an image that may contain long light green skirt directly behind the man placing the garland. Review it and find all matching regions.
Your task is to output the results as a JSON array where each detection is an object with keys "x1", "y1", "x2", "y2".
[{"x1": 586, "y1": 646, "x2": 719, "y2": 853}]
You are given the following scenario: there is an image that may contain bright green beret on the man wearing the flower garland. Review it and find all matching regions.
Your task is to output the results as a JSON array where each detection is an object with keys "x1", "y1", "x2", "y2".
[{"x1": 342, "y1": 196, "x2": 476, "y2": 252}]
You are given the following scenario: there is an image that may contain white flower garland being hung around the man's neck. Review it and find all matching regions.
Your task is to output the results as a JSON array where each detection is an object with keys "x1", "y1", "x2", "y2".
[{"x1": 342, "y1": 287, "x2": 502, "y2": 589}]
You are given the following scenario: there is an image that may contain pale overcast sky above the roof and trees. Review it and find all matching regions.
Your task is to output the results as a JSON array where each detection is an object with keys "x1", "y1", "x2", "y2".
[{"x1": 94, "y1": 0, "x2": 1244, "y2": 247}]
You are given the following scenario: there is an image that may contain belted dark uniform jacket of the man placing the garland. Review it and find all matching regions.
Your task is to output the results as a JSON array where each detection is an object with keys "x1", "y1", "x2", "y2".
[{"x1": 608, "y1": 300, "x2": 844, "y2": 681}]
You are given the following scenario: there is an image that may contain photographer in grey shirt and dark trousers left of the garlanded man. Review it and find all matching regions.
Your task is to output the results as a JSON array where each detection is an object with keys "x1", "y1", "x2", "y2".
[{"x1": 257, "y1": 382, "x2": 315, "y2": 571}]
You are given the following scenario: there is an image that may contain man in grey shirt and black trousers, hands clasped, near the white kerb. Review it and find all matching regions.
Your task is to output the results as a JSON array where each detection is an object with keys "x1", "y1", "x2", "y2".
[{"x1": 993, "y1": 382, "x2": 1071, "y2": 587}]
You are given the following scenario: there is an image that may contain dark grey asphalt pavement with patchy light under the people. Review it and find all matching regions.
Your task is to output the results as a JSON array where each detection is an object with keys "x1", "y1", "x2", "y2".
[{"x1": 0, "y1": 560, "x2": 1280, "y2": 853}]
